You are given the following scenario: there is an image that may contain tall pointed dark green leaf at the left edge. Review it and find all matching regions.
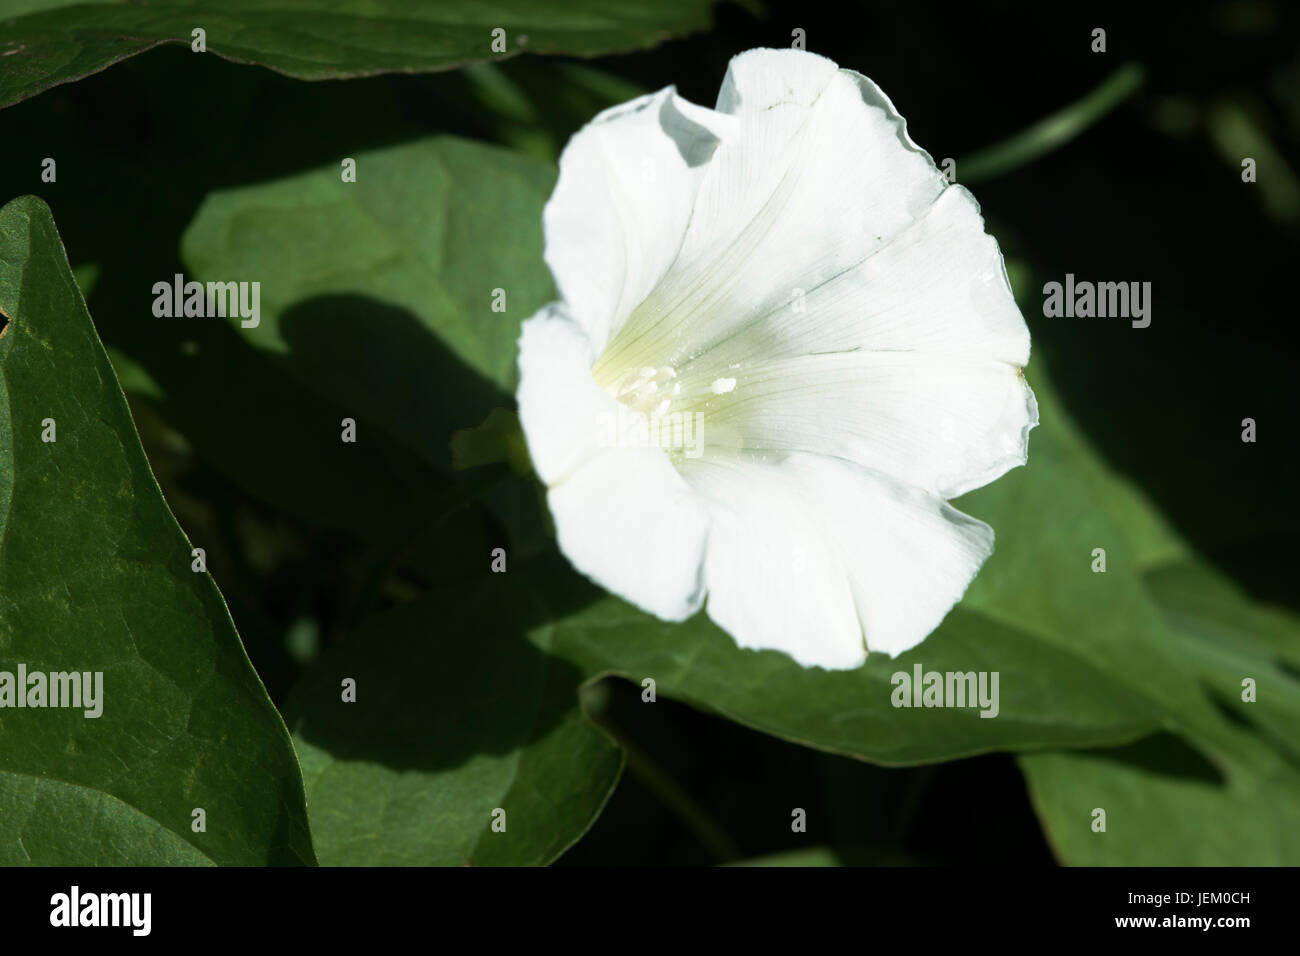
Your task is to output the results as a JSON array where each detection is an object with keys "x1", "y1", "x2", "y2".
[{"x1": 0, "y1": 196, "x2": 315, "y2": 865}]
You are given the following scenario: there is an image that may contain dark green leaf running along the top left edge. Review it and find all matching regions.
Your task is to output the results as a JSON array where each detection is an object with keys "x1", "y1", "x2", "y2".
[{"x1": 0, "y1": 0, "x2": 710, "y2": 107}]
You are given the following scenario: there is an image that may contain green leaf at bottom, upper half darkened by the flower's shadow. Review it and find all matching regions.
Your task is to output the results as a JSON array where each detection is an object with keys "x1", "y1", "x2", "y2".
[{"x1": 286, "y1": 574, "x2": 623, "y2": 866}]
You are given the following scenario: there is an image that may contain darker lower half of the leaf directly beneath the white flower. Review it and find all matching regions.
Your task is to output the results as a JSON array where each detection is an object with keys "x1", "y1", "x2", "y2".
[{"x1": 538, "y1": 580, "x2": 1156, "y2": 765}]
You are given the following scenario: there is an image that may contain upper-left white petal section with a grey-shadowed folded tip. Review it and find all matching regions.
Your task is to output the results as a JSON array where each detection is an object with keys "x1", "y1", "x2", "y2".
[{"x1": 543, "y1": 87, "x2": 735, "y2": 350}]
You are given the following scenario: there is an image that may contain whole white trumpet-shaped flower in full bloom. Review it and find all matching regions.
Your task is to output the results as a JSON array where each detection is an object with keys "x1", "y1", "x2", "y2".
[{"x1": 519, "y1": 49, "x2": 1037, "y2": 669}]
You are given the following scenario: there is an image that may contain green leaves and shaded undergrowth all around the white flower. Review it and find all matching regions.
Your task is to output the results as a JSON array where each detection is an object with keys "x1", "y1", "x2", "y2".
[{"x1": 0, "y1": 0, "x2": 1300, "y2": 865}]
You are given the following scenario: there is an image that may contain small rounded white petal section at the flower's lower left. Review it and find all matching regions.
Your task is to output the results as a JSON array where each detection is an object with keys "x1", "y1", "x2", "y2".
[{"x1": 547, "y1": 447, "x2": 709, "y2": 620}]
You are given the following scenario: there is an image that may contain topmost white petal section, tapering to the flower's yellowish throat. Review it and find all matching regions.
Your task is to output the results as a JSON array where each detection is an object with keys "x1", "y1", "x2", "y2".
[{"x1": 598, "y1": 49, "x2": 946, "y2": 368}]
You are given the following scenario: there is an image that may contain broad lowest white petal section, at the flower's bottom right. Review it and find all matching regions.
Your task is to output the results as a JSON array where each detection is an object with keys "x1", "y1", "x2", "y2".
[{"x1": 684, "y1": 455, "x2": 993, "y2": 669}]
